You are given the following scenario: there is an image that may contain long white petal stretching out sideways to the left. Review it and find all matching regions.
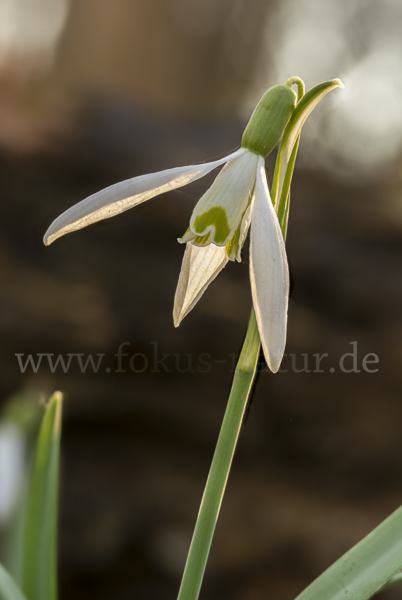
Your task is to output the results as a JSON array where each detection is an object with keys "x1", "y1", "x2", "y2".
[{"x1": 43, "y1": 148, "x2": 247, "y2": 245}]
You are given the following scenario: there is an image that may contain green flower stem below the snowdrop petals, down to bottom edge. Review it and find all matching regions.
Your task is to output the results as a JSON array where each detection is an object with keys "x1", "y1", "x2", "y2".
[{"x1": 178, "y1": 309, "x2": 260, "y2": 600}]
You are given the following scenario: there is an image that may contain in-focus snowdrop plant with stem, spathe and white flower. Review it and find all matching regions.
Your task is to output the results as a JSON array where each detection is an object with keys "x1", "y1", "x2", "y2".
[{"x1": 44, "y1": 77, "x2": 343, "y2": 600}]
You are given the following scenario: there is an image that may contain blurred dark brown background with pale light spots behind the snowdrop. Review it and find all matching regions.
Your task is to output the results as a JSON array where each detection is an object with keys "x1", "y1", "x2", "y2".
[{"x1": 0, "y1": 0, "x2": 402, "y2": 600}]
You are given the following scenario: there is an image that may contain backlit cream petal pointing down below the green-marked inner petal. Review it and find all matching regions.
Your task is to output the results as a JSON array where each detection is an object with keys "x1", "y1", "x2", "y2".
[{"x1": 173, "y1": 243, "x2": 228, "y2": 327}]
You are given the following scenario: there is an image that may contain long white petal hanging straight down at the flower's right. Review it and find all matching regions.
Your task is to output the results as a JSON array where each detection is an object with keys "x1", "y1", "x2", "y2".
[{"x1": 250, "y1": 158, "x2": 289, "y2": 373}]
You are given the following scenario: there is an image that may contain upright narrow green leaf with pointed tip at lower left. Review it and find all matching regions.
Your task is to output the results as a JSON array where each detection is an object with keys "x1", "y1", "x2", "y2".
[{"x1": 22, "y1": 392, "x2": 63, "y2": 600}]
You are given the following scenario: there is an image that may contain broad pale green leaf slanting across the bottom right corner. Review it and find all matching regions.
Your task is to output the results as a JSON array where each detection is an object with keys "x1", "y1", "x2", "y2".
[{"x1": 296, "y1": 507, "x2": 402, "y2": 600}]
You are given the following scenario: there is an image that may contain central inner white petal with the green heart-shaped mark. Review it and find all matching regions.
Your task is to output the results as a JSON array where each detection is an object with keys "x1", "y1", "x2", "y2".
[{"x1": 190, "y1": 150, "x2": 258, "y2": 246}]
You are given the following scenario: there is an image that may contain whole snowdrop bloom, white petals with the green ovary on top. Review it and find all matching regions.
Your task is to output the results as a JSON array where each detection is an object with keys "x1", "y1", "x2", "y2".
[{"x1": 44, "y1": 78, "x2": 346, "y2": 372}]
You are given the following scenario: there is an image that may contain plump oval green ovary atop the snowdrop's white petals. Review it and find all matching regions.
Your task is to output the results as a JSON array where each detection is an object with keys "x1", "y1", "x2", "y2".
[{"x1": 241, "y1": 85, "x2": 296, "y2": 158}]
